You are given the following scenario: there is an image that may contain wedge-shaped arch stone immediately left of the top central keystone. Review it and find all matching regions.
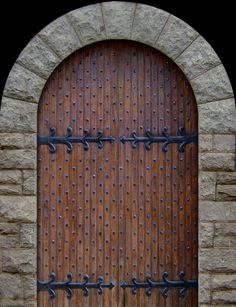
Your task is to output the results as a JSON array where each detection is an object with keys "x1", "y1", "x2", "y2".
[{"x1": 67, "y1": 4, "x2": 106, "y2": 45}]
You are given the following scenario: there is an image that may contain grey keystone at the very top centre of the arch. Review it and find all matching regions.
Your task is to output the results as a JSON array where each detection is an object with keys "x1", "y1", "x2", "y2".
[{"x1": 102, "y1": 1, "x2": 135, "y2": 39}]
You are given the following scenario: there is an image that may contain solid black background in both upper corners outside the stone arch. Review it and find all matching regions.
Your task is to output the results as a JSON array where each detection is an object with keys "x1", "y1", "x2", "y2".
[{"x1": 0, "y1": 0, "x2": 236, "y2": 104}]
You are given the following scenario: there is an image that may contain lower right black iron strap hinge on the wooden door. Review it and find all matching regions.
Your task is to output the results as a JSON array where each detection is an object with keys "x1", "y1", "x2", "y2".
[{"x1": 120, "y1": 272, "x2": 198, "y2": 298}]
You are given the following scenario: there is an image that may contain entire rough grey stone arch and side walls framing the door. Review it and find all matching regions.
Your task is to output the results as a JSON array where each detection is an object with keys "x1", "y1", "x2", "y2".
[{"x1": 0, "y1": 1, "x2": 236, "y2": 307}]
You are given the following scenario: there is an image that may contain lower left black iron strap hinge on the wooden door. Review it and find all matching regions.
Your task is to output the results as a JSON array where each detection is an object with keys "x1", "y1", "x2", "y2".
[{"x1": 38, "y1": 273, "x2": 115, "y2": 299}]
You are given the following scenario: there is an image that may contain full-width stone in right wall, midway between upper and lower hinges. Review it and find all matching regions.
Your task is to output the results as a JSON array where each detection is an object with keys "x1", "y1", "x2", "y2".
[{"x1": 199, "y1": 201, "x2": 236, "y2": 222}]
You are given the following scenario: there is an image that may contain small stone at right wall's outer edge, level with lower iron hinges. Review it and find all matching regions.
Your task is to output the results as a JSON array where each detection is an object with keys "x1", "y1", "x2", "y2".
[{"x1": 211, "y1": 274, "x2": 236, "y2": 289}]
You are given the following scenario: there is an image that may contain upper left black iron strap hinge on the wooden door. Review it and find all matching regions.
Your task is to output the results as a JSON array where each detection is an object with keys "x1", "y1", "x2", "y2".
[{"x1": 38, "y1": 127, "x2": 115, "y2": 153}]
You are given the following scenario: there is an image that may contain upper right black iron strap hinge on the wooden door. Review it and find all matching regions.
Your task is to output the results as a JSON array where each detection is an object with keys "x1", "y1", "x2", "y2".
[{"x1": 120, "y1": 125, "x2": 197, "y2": 152}]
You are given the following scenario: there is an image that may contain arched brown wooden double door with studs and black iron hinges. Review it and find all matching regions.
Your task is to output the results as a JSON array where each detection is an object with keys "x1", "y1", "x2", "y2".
[{"x1": 38, "y1": 41, "x2": 198, "y2": 307}]
